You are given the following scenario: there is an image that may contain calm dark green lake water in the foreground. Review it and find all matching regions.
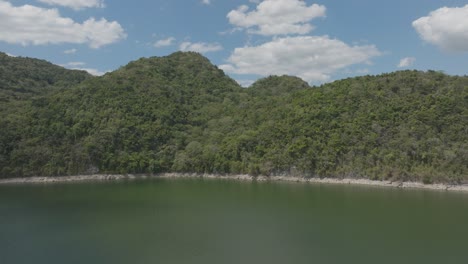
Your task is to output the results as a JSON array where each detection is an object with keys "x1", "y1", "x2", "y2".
[{"x1": 0, "y1": 179, "x2": 468, "y2": 264}]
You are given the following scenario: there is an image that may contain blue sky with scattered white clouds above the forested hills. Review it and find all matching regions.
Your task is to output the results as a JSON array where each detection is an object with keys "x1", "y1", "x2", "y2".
[{"x1": 0, "y1": 0, "x2": 468, "y2": 86}]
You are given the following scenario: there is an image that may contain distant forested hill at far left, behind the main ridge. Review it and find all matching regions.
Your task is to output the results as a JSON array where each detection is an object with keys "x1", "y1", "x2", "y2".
[{"x1": 0, "y1": 52, "x2": 91, "y2": 103}]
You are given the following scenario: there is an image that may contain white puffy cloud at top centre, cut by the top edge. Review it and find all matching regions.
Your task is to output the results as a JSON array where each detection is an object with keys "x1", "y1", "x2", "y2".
[{"x1": 227, "y1": 0, "x2": 326, "y2": 36}]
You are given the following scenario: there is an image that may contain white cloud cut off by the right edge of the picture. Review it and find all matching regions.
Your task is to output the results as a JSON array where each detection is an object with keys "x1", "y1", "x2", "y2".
[{"x1": 413, "y1": 5, "x2": 468, "y2": 52}]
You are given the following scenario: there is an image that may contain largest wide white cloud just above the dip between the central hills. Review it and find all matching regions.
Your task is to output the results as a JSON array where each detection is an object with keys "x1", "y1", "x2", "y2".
[{"x1": 219, "y1": 36, "x2": 381, "y2": 83}]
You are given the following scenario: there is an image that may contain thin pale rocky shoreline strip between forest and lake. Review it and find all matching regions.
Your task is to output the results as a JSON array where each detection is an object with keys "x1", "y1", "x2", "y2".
[{"x1": 0, "y1": 173, "x2": 468, "y2": 192}]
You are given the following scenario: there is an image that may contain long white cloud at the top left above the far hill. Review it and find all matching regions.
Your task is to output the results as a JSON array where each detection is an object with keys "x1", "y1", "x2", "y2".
[{"x1": 0, "y1": 0, "x2": 127, "y2": 48}]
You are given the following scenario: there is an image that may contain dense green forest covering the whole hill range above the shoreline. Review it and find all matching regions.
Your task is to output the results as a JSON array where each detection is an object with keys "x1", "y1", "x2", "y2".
[{"x1": 0, "y1": 52, "x2": 468, "y2": 183}]
